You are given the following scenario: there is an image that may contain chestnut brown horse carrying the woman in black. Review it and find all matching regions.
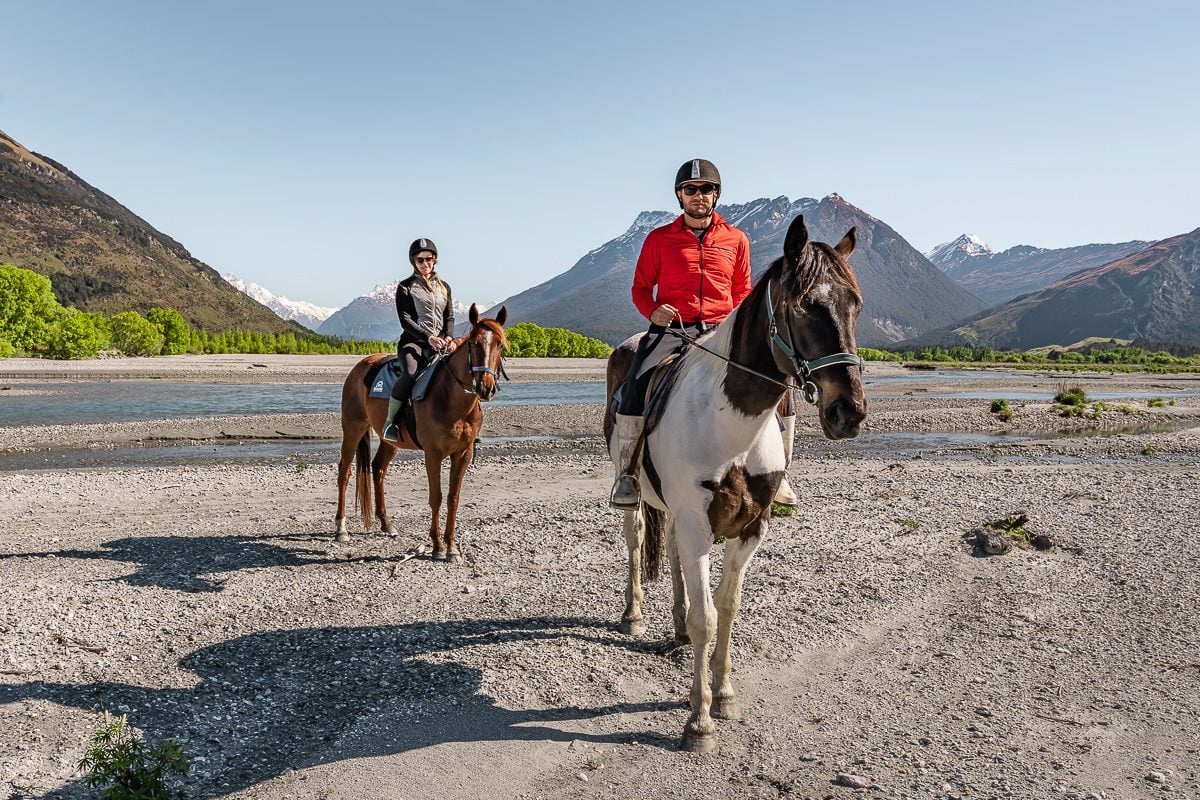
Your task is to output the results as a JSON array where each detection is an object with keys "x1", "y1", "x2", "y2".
[{"x1": 335, "y1": 305, "x2": 509, "y2": 561}]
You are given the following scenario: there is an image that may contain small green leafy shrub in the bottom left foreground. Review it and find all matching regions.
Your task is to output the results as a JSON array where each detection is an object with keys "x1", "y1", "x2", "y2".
[{"x1": 79, "y1": 711, "x2": 187, "y2": 800}]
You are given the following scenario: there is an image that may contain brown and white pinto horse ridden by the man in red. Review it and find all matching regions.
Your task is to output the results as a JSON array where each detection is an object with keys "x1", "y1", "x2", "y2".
[{"x1": 605, "y1": 217, "x2": 866, "y2": 752}]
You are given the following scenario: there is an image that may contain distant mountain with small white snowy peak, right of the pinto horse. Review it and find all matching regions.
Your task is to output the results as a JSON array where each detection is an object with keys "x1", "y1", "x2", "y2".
[{"x1": 925, "y1": 234, "x2": 1150, "y2": 305}]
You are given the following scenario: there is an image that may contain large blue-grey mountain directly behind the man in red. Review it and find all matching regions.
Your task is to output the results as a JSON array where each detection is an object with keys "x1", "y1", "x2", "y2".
[{"x1": 492, "y1": 194, "x2": 986, "y2": 347}]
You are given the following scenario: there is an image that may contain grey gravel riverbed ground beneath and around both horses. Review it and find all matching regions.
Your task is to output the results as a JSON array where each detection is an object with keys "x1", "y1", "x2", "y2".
[{"x1": 0, "y1": 357, "x2": 1200, "y2": 800}]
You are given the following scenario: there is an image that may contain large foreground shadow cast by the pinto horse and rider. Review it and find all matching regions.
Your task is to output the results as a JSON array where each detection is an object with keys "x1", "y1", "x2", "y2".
[{"x1": 0, "y1": 616, "x2": 679, "y2": 799}]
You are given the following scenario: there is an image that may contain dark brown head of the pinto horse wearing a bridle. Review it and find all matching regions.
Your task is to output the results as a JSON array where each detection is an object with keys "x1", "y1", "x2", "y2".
[{"x1": 767, "y1": 216, "x2": 866, "y2": 439}]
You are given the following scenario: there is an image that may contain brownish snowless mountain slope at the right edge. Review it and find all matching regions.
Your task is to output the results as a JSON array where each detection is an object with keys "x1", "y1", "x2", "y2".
[{"x1": 912, "y1": 228, "x2": 1200, "y2": 350}]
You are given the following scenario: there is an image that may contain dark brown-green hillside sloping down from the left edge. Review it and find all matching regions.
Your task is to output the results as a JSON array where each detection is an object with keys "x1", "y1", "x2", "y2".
[{"x1": 0, "y1": 132, "x2": 301, "y2": 333}]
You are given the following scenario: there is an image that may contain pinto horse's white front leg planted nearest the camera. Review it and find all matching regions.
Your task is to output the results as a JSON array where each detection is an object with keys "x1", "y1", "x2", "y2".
[{"x1": 674, "y1": 515, "x2": 716, "y2": 753}]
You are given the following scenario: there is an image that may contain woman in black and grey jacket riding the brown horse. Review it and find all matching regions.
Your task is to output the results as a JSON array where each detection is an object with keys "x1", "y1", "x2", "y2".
[{"x1": 383, "y1": 239, "x2": 454, "y2": 441}]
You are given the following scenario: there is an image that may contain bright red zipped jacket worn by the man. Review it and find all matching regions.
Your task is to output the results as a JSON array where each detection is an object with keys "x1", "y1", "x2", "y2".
[{"x1": 632, "y1": 211, "x2": 750, "y2": 323}]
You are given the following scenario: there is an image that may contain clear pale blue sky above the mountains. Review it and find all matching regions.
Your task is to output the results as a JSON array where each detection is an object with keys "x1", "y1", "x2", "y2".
[{"x1": 0, "y1": 0, "x2": 1200, "y2": 306}]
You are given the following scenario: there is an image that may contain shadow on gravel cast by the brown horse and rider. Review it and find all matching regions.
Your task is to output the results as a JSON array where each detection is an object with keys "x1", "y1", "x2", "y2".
[{"x1": 0, "y1": 536, "x2": 384, "y2": 591}]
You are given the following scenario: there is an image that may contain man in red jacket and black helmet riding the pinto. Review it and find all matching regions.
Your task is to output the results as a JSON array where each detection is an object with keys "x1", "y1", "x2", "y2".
[{"x1": 608, "y1": 158, "x2": 797, "y2": 509}]
